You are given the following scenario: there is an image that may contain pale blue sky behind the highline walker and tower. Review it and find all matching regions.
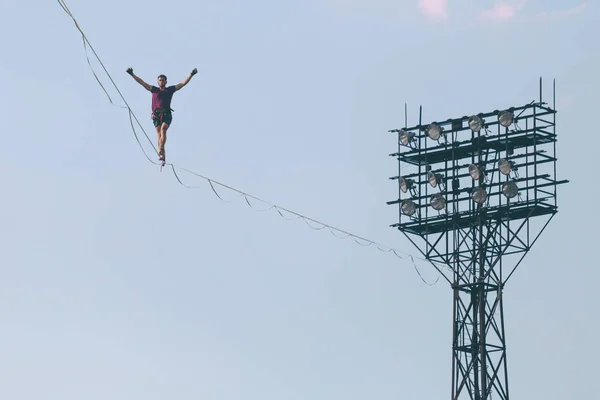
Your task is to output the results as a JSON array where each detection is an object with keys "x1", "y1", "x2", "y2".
[{"x1": 0, "y1": 0, "x2": 600, "y2": 400}]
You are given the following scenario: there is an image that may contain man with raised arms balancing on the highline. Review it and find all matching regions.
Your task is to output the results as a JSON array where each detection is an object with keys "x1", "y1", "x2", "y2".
[{"x1": 127, "y1": 68, "x2": 198, "y2": 164}]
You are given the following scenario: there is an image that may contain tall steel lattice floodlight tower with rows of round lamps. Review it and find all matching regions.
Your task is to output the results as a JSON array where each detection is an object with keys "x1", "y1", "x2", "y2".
[{"x1": 388, "y1": 79, "x2": 568, "y2": 400}]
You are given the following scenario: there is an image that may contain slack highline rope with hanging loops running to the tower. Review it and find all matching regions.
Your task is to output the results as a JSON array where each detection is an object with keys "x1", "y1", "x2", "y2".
[{"x1": 57, "y1": 0, "x2": 451, "y2": 286}]
